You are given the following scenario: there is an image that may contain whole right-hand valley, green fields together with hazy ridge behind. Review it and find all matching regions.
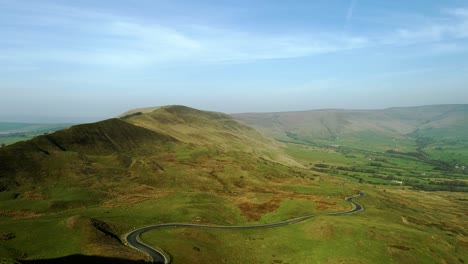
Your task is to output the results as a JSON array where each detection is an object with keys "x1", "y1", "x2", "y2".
[{"x1": 235, "y1": 105, "x2": 468, "y2": 192}]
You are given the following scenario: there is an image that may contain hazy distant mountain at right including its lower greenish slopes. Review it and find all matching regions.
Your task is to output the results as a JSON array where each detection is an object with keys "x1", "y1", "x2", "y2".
[{"x1": 232, "y1": 105, "x2": 468, "y2": 158}]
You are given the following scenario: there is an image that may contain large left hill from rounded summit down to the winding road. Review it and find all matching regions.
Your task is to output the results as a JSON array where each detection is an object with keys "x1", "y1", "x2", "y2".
[{"x1": 0, "y1": 106, "x2": 310, "y2": 259}]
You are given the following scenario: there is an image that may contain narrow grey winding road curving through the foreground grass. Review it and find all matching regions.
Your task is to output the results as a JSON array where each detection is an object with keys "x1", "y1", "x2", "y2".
[{"x1": 124, "y1": 192, "x2": 365, "y2": 264}]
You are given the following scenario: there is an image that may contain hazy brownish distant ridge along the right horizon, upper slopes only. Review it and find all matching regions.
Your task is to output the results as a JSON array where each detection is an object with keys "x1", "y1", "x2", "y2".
[{"x1": 232, "y1": 105, "x2": 468, "y2": 140}]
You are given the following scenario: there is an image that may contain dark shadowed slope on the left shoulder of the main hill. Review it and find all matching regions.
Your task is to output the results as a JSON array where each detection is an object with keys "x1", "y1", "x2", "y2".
[{"x1": 0, "y1": 119, "x2": 177, "y2": 190}]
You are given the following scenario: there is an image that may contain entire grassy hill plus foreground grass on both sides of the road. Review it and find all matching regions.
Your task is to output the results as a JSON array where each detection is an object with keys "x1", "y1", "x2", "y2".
[{"x1": 0, "y1": 106, "x2": 468, "y2": 263}]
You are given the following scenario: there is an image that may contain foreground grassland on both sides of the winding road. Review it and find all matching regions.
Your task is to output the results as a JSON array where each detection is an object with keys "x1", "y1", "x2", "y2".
[{"x1": 0, "y1": 182, "x2": 468, "y2": 263}]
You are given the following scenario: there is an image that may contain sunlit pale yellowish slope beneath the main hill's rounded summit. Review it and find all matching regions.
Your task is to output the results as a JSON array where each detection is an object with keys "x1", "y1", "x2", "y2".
[{"x1": 123, "y1": 105, "x2": 298, "y2": 166}]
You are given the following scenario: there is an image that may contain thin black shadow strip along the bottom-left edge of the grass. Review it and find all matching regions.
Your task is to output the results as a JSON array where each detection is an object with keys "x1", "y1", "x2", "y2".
[{"x1": 19, "y1": 255, "x2": 149, "y2": 264}]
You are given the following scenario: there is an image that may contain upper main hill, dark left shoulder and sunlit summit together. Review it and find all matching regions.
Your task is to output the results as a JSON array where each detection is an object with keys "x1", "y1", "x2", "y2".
[{"x1": 0, "y1": 106, "x2": 298, "y2": 190}]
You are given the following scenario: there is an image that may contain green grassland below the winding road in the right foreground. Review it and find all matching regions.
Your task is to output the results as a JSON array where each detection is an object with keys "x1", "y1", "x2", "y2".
[{"x1": 143, "y1": 188, "x2": 468, "y2": 263}]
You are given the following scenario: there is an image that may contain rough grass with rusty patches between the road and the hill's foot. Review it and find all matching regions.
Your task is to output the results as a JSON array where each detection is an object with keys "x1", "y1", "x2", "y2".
[{"x1": 0, "y1": 165, "x2": 353, "y2": 263}]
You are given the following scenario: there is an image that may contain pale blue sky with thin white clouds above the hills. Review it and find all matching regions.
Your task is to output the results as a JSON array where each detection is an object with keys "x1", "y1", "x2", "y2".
[{"x1": 0, "y1": 0, "x2": 468, "y2": 122}]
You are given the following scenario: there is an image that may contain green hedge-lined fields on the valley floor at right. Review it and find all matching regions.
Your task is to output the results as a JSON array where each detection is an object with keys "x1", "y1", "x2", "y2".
[{"x1": 282, "y1": 128, "x2": 468, "y2": 192}]
